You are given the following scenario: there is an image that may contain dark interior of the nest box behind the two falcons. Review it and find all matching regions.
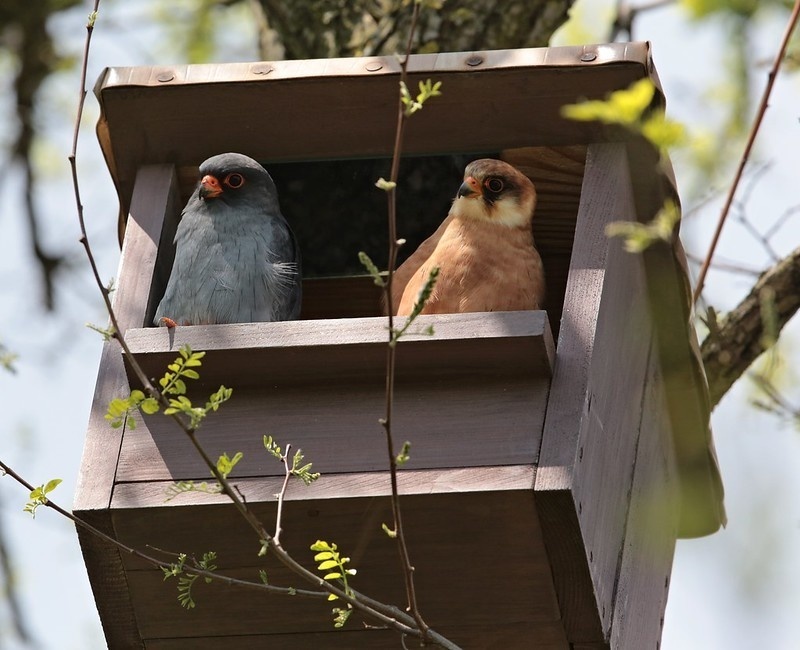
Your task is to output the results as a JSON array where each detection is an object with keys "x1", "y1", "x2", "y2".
[{"x1": 147, "y1": 145, "x2": 586, "y2": 336}]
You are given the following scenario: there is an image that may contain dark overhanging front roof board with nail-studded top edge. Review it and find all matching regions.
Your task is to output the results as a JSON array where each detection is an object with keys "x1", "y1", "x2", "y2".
[{"x1": 95, "y1": 43, "x2": 651, "y2": 219}]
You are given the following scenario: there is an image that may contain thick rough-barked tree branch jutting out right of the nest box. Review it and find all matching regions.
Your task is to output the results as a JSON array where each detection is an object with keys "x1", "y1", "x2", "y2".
[{"x1": 700, "y1": 247, "x2": 800, "y2": 408}]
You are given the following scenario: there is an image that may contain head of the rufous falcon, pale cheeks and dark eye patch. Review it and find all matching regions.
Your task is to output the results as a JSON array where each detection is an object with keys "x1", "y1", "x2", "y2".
[{"x1": 452, "y1": 158, "x2": 536, "y2": 227}]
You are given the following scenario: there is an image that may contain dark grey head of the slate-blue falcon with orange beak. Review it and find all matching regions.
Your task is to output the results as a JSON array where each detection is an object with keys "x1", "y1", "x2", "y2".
[{"x1": 197, "y1": 153, "x2": 277, "y2": 205}]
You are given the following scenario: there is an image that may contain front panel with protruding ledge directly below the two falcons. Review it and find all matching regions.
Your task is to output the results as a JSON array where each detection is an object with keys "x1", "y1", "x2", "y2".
[{"x1": 116, "y1": 312, "x2": 552, "y2": 482}]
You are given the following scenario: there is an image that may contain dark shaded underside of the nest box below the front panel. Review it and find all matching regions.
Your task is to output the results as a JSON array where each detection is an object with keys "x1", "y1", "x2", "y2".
[{"x1": 114, "y1": 490, "x2": 566, "y2": 646}]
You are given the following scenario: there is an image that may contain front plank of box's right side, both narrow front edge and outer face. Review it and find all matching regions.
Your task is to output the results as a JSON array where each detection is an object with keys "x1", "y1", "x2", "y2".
[{"x1": 536, "y1": 140, "x2": 649, "y2": 642}]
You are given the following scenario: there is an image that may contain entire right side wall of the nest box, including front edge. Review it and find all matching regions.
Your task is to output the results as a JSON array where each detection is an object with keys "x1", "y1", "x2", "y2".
[{"x1": 536, "y1": 143, "x2": 675, "y2": 647}]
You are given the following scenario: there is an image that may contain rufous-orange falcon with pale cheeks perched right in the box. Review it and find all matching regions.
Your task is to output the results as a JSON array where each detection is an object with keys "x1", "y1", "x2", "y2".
[{"x1": 392, "y1": 158, "x2": 545, "y2": 316}]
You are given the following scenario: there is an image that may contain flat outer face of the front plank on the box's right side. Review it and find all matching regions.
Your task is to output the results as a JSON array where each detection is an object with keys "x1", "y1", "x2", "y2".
[{"x1": 573, "y1": 201, "x2": 652, "y2": 636}]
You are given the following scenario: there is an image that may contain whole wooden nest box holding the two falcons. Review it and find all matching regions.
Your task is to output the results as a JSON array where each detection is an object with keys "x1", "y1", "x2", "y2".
[{"x1": 75, "y1": 43, "x2": 724, "y2": 650}]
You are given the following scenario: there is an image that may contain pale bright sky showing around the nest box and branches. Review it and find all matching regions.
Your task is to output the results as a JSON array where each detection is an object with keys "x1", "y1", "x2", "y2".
[{"x1": 0, "y1": 0, "x2": 800, "y2": 650}]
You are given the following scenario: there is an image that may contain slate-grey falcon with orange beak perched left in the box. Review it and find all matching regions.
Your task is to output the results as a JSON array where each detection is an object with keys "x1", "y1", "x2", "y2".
[{"x1": 154, "y1": 153, "x2": 302, "y2": 325}]
